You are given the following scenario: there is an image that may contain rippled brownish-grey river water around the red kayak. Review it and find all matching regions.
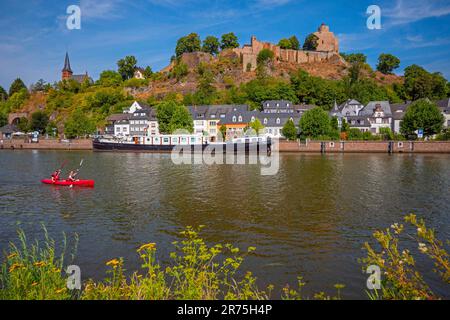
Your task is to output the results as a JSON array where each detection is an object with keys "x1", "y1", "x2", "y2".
[{"x1": 0, "y1": 151, "x2": 450, "y2": 299}]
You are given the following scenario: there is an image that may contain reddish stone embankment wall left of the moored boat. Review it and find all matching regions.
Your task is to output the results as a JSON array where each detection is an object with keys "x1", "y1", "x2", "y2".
[{"x1": 0, "y1": 139, "x2": 92, "y2": 150}]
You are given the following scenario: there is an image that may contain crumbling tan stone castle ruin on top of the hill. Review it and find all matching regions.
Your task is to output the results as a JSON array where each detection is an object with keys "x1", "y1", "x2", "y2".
[{"x1": 233, "y1": 23, "x2": 340, "y2": 71}]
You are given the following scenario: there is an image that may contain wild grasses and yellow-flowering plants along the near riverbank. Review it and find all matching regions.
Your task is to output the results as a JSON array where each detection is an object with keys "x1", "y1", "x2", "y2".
[{"x1": 0, "y1": 215, "x2": 450, "y2": 300}]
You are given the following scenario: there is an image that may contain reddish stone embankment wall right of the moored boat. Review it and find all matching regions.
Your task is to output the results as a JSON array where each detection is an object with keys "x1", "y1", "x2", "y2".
[{"x1": 279, "y1": 141, "x2": 450, "y2": 154}]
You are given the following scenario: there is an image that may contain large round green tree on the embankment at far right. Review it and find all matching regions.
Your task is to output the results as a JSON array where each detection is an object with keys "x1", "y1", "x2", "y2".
[{"x1": 400, "y1": 99, "x2": 445, "y2": 136}]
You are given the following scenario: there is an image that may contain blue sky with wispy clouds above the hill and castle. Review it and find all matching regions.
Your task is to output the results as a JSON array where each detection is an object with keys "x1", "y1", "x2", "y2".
[{"x1": 0, "y1": 0, "x2": 450, "y2": 89}]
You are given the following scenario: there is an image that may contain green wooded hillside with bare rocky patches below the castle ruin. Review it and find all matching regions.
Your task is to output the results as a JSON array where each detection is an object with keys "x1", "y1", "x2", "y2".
[{"x1": 0, "y1": 34, "x2": 450, "y2": 136}]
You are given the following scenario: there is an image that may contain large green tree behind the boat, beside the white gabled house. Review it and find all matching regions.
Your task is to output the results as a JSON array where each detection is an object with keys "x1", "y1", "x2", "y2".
[{"x1": 156, "y1": 101, "x2": 194, "y2": 134}]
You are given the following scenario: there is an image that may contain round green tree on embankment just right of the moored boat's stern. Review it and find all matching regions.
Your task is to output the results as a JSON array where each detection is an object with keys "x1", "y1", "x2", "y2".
[{"x1": 299, "y1": 107, "x2": 331, "y2": 138}]
